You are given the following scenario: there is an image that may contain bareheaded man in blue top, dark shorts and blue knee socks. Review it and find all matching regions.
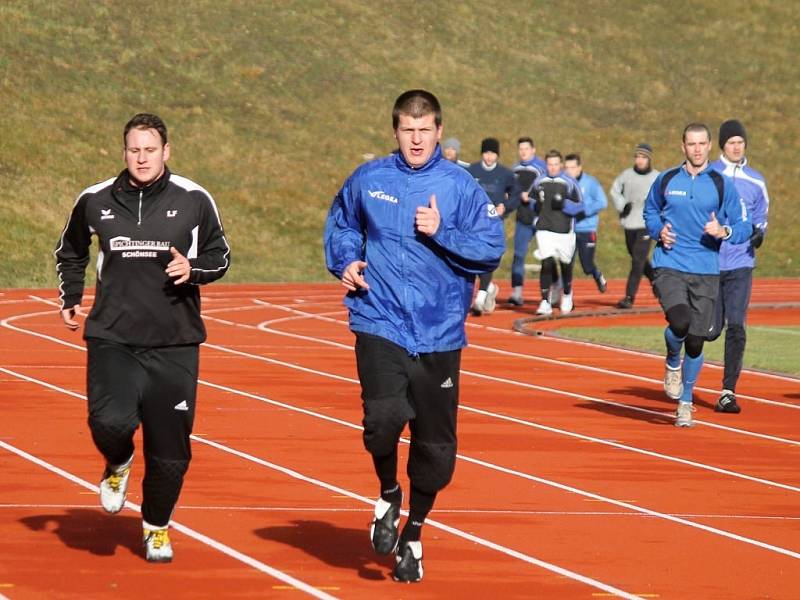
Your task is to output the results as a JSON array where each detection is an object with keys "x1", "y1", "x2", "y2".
[{"x1": 644, "y1": 123, "x2": 752, "y2": 427}]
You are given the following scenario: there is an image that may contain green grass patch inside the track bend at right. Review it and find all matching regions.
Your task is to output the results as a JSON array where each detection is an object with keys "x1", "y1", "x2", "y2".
[{"x1": 557, "y1": 325, "x2": 800, "y2": 375}]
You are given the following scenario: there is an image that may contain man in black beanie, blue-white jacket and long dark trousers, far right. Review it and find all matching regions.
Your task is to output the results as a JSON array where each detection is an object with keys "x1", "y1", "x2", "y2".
[{"x1": 709, "y1": 120, "x2": 769, "y2": 414}]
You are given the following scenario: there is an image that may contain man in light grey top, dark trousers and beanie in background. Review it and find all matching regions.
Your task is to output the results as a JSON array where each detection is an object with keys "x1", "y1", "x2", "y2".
[{"x1": 609, "y1": 144, "x2": 659, "y2": 309}]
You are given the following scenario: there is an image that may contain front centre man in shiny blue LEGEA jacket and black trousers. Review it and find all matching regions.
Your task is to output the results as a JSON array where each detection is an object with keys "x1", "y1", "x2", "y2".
[{"x1": 324, "y1": 90, "x2": 505, "y2": 582}]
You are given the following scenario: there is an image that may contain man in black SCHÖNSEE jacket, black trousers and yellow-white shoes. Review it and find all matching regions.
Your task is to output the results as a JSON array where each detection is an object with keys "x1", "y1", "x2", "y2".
[{"x1": 55, "y1": 113, "x2": 230, "y2": 562}]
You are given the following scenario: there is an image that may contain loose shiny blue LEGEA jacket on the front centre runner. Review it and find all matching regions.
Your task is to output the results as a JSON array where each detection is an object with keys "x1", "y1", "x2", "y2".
[{"x1": 324, "y1": 146, "x2": 505, "y2": 355}]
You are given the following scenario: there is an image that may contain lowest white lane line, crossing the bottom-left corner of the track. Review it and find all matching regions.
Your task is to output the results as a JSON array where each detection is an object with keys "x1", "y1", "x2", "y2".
[{"x1": 0, "y1": 440, "x2": 334, "y2": 600}]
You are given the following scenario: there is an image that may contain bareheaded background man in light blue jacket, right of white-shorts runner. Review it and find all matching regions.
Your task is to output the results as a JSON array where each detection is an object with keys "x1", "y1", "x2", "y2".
[{"x1": 564, "y1": 153, "x2": 608, "y2": 294}]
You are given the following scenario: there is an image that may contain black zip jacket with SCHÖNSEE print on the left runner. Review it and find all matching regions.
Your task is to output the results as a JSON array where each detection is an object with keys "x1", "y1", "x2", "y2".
[{"x1": 55, "y1": 170, "x2": 230, "y2": 347}]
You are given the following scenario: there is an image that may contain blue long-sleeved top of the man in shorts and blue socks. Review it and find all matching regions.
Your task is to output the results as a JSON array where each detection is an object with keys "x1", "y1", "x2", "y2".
[{"x1": 644, "y1": 163, "x2": 753, "y2": 275}]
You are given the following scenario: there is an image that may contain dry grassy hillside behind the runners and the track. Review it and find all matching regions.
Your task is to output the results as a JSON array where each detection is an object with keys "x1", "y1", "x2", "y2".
[{"x1": 0, "y1": 0, "x2": 800, "y2": 286}]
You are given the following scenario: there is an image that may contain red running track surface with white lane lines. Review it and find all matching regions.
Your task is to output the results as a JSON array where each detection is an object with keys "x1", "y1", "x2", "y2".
[{"x1": 0, "y1": 280, "x2": 800, "y2": 599}]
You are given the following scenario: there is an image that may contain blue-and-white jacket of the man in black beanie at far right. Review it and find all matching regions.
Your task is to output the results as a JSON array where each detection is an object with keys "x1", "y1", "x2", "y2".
[{"x1": 711, "y1": 156, "x2": 769, "y2": 271}]
